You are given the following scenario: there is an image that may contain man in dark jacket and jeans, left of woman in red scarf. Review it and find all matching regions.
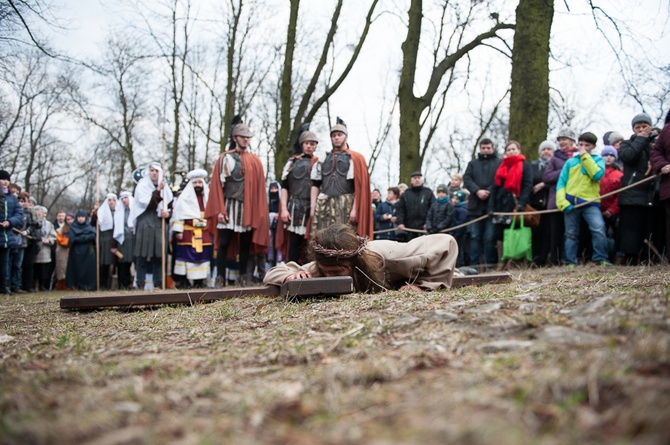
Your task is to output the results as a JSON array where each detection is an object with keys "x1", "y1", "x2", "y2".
[{"x1": 463, "y1": 139, "x2": 502, "y2": 267}]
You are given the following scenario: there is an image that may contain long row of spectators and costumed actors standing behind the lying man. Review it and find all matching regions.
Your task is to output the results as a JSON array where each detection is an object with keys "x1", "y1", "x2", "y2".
[{"x1": 0, "y1": 109, "x2": 670, "y2": 294}]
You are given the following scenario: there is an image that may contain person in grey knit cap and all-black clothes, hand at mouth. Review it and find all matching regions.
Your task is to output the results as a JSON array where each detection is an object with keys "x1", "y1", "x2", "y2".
[{"x1": 619, "y1": 113, "x2": 664, "y2": 262}]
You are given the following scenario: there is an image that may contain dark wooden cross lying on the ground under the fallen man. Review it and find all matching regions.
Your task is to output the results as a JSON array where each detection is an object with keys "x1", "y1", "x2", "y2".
[{"x1": 60, "y1": 273, "x2": 512, "y2": 310}]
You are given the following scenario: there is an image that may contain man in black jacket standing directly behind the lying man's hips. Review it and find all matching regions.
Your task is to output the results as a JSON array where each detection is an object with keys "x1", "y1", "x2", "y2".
[{"x1": 397, "y1": 171, "x2": 435, "y2": 241}]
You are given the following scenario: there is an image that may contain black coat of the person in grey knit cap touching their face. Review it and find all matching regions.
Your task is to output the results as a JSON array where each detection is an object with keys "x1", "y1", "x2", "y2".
[{"x1": 619, "y1": 135, "x2": 657, "y2": 207}]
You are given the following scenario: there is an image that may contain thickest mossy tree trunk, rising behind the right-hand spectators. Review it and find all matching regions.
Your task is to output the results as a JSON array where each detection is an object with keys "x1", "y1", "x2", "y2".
[{"x1": 509, "y1": 0, "x2": 554, "y2": 159}]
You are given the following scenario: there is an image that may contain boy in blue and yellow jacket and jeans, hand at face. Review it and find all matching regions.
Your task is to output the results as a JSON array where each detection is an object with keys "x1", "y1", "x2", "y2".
[{"x1": 556, "y1": 132, "x2": 612, "y2": 267}]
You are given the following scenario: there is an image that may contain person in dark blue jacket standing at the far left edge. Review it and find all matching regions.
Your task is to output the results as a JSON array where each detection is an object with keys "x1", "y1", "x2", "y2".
[{"x1": 0, "y1": 170, "x2": 23, "y2": 295}]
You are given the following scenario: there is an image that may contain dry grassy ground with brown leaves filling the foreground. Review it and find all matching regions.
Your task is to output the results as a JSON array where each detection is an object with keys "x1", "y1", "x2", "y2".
[{"x1": 0, "y1": 267, "x2": 670, "y2": 445}]
